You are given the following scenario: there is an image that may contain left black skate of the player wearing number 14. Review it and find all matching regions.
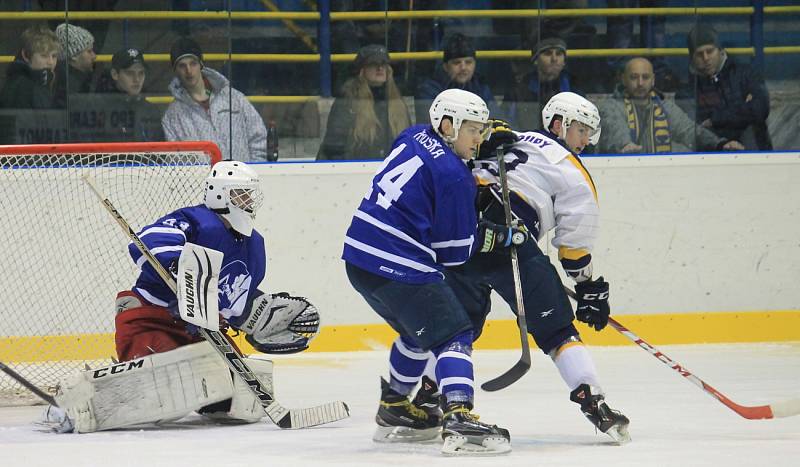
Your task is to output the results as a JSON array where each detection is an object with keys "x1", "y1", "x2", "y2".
[{"x1": 372, "y1": 378, "x2": 442, "y2": 443}]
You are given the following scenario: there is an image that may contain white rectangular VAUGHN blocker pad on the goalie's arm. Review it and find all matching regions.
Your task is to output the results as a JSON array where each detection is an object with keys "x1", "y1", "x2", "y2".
[{"x1": 176, "y1": 242, "x2": 224, "y2": 330}]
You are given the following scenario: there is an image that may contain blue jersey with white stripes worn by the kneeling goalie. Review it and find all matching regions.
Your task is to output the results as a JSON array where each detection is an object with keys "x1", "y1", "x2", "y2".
[{"x1": 128, "y1": 205, "x2": 267, "y2": 319}]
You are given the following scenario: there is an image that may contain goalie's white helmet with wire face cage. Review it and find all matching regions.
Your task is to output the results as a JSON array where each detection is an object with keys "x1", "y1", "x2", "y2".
[{"x1": 205, "y1": 161, "x2": 264, "y2": 237}]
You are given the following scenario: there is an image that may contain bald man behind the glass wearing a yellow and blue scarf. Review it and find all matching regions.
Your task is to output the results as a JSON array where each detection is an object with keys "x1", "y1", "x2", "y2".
[{"x1": 599, "y1": 57, "x2": 744, "y2": 153}]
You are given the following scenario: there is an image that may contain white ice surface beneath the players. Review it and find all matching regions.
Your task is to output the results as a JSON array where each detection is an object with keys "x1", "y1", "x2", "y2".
[{"x1": 0, "y1": 344, "x2": 800, "y2": 467}]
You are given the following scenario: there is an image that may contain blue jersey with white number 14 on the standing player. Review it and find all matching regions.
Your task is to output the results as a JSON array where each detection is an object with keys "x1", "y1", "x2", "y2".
[{"x1": 342, "y1": 125, "x2": 478, "y2": 284}]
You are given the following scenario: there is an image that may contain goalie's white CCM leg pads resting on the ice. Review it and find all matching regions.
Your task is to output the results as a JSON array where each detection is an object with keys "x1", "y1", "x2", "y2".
[{"x1": 55, "y1": 342, "x2": 272, "y2": 433}]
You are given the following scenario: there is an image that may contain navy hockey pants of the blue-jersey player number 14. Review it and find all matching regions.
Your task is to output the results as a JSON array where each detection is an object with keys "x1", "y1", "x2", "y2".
[{"x1": 345, "y1": 263, "x2": 472, "y2": 351}]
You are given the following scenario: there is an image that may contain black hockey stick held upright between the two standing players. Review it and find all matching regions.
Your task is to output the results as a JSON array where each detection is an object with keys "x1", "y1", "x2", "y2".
[{"x1": 481, "y1": 147, "x2": 531, "y2": 391}]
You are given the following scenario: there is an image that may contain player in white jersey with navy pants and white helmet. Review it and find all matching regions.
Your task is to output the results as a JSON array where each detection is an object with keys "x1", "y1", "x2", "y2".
[{"x1": 448, "y1": 92, "x2": 630, "y2": 443}]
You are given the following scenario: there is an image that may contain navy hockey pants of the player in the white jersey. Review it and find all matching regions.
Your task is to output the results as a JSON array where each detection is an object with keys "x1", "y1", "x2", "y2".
[{"x1": 446, "y1": 240, "x2": 578, "y2": 353}]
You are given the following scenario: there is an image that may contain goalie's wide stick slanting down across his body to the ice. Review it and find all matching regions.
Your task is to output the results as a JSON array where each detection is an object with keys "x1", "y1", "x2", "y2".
[{"x1": 83, "y1": 174, "x2": 350, "y2": 428}]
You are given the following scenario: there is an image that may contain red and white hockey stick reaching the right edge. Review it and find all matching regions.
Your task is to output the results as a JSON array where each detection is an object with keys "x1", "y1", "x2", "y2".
[{"x1": 564, "y1": 287, "x2": 800, "y2": 420}]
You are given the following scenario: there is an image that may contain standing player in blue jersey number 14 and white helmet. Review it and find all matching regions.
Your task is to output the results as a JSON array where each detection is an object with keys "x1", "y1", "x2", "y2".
[{"x1": 342, "y1": 89, "x2": 524, "y2": 454}]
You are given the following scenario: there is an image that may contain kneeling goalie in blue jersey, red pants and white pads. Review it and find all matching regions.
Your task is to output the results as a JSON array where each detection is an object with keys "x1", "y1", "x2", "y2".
[{"x1": 45, "y1": 161, "x2": 319, "y2": 433}]
